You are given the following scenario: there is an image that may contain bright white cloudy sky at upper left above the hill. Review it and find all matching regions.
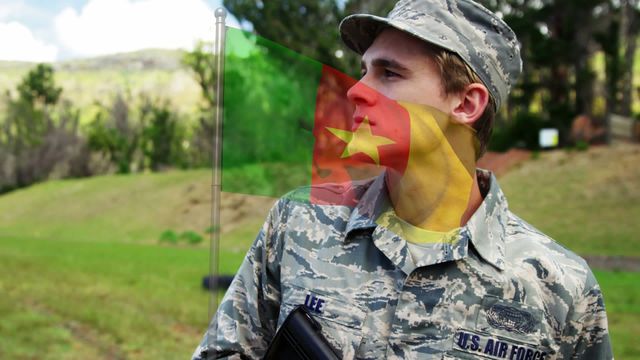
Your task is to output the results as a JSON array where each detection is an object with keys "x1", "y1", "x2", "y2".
[{"x1": 0, "y1": 0, "x2": 237, "y2": 62}]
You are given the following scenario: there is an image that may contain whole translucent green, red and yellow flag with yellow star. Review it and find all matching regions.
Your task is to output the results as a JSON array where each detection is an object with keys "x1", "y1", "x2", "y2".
[{"x1": 222, "y1": 28, "x2": 476, "y2": 231}]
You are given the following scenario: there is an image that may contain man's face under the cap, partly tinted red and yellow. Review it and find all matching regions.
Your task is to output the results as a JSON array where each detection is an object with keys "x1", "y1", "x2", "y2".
[{"x1": 347, "y1": 29, "x2": 455, "y2": 173}]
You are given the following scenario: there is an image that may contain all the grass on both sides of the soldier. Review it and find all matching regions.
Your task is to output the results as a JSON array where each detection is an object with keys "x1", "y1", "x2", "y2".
[{"x1": 0, "y1": 147, "x2": 640, "y2": 359}]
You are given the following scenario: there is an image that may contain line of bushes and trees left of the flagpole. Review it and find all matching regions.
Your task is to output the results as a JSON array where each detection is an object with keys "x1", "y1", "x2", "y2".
[{"x1": 0, "y1": 64, "x2": 211, "y2": 193}]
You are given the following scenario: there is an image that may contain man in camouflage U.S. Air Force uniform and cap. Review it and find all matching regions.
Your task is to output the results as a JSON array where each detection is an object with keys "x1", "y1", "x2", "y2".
[{"x1": 194, "y1": 0, "x2": 612, "y2": 360}]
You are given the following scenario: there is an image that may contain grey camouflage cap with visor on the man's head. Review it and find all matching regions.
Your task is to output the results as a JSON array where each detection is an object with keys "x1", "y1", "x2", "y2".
[{"x1": 340, "y1": 0, "x2": 522, "y2": 108}]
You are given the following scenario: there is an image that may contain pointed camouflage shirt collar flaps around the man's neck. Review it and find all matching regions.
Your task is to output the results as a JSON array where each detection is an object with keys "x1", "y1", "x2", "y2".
[{"x1": 346, "y1": 169, "x2": 508, "y2": 270}]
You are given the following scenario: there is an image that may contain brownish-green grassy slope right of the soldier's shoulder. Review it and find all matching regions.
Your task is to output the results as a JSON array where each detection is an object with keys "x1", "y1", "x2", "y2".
[{"x1": 500, "y1": 145, "x2": 640, "y2": 256}]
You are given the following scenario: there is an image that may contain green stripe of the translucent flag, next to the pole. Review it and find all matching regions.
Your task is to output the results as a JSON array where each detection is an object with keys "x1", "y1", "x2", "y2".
[{"x1": 222, "y1": 28, "x2": 322, "y2": 196}]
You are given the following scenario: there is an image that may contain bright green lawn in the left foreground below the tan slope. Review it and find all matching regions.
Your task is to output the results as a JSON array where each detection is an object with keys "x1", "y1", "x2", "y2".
[{"x1": 0, "y1": 237, "x2": 244, "y2": 359}]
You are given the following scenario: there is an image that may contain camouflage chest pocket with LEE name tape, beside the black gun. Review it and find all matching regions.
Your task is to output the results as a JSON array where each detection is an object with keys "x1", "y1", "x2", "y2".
[{"x1": 278, "y1": 285, "x2": 366, "y2": 359}]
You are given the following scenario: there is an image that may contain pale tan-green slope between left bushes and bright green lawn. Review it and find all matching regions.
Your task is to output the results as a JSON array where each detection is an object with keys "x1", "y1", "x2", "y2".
[{"x1": 0, "y1": 170, "x2": 273, "y2": 244}]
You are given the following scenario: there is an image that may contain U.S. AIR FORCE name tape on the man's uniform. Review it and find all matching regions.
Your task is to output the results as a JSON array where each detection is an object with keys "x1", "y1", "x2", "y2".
[{"x1": 453, "y1": 329, "x2": 549, "y2": 360}]
